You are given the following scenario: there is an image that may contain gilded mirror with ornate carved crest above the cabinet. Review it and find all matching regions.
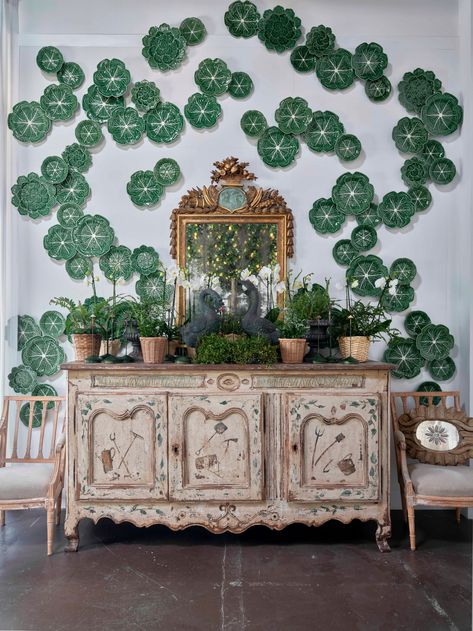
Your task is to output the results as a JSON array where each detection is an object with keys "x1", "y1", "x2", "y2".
[{"x1": 171, "y1": 157, "x2": 294, "y2": 322}]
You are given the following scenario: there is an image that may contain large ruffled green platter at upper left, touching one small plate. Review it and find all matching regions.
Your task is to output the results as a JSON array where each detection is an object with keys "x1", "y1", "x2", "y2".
[{"x1": 142, "y1": 23, "x2": 187, "y2": 72}]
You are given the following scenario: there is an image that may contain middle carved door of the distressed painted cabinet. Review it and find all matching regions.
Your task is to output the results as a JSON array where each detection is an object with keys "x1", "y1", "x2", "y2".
[{"x1": 169, "y1": 394, "x2": 263, "y2": 500}]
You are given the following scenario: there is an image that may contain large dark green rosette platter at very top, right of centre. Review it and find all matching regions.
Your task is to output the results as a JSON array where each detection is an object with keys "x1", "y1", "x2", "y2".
[{"x1": 258, "y1": 5, "x2": 301, "y2": 53}]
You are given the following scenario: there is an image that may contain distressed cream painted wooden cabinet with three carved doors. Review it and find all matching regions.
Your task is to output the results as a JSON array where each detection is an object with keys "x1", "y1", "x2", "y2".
[{"x1": 63, "y1": 362, "x2": 391, "y2": 551}]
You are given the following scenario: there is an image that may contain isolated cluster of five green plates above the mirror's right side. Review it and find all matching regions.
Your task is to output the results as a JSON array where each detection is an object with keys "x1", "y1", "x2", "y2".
[{"x1": 240, "y1": 96, "x2": 361, "y2": 167}]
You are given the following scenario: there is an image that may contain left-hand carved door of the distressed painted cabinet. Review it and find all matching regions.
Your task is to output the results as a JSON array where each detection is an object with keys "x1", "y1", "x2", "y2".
[{"x1": 75, "y1": 392, "x2": 167, "y2": 501}]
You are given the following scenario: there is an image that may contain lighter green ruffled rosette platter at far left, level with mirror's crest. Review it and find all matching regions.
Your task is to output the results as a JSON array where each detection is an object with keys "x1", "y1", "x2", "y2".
[{"x1": 11, "y1": 173, "x2": 56, "y2": 219}]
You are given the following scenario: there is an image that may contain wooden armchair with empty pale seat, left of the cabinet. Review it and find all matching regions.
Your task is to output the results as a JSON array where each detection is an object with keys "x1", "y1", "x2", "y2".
[{"x1": 0, "y1": 396, "x2": 66, "y2": 555}]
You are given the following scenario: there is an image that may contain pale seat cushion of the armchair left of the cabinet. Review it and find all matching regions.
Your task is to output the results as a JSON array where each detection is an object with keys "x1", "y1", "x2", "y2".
[{"x1": 0, "y1": 462, "x2": 54, "y2": 502}]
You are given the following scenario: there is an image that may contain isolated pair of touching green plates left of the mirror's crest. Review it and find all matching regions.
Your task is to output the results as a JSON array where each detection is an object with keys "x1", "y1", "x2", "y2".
[{"x1": 126, "y1": 158, "x2": 181, "y2": 207}]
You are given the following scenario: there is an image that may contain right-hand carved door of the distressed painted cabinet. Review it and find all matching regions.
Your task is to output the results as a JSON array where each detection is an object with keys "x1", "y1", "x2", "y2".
[{"x1": 285, "y1": 393, "x2": 382, "y2": 501}]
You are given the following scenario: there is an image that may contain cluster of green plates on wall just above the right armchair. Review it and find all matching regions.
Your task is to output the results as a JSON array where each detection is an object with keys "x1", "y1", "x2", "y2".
[{"x1": 384, "y1": 311, "x2": 456, "y2": 382}]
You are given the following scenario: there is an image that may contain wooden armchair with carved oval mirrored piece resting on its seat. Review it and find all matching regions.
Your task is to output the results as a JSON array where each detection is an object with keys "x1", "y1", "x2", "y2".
[{"x1": 391, "y1": 392, "x2": 473, "y2": 550}]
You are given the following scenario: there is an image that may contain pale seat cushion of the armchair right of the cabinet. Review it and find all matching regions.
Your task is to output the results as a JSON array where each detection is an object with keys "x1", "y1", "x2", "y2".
[{"x1": 408, "y1": 462, "x2": 473, "y2": 497}]
